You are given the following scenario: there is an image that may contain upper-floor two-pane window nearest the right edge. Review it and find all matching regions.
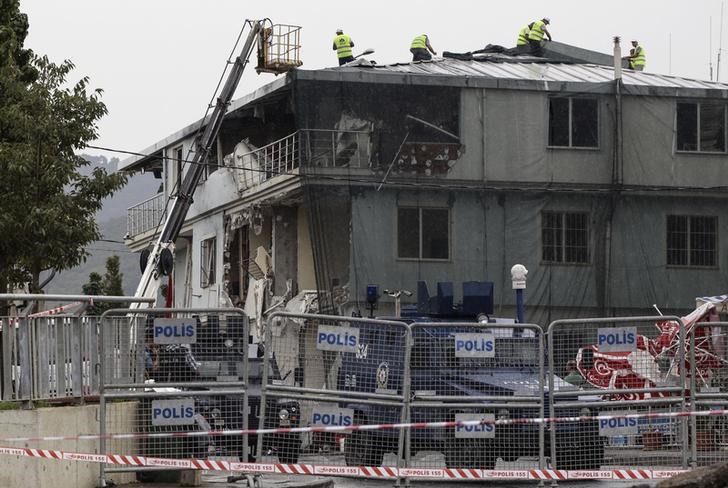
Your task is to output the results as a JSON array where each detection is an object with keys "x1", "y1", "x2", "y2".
[{"x1": 676, "y1": 102, "x2": 726, "y2": 152}]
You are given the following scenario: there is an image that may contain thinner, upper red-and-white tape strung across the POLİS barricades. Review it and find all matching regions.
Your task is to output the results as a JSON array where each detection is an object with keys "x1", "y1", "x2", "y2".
[{"x1": 0, "y1": 410, "x2": 728, "y2": 442}]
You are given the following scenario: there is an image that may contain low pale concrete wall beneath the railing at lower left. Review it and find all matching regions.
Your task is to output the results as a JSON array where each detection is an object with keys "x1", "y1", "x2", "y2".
[{"x1": 0, "y1": 402, "x2": 137, "y2": 488}]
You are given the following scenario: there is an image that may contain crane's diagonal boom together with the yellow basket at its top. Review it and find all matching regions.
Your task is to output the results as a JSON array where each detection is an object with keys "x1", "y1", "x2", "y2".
[{"x1": 132, "y1": 19, "x2": 301, "y2": 308}]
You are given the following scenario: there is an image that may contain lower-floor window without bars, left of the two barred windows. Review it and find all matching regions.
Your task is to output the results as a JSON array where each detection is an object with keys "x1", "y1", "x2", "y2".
[{"x1": 397, "y1": 207, "x2": 450, "y2": 259}]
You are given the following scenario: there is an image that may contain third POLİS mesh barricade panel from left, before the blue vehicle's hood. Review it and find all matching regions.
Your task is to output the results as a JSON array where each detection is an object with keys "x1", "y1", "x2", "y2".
[{"x1": 406, "y1": 322, "x2": 544, "y2": 470}]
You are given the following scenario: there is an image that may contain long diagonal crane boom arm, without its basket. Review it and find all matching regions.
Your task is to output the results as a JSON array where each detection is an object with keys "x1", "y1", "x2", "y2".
[{"x1": 132, "y1": 20, "x2": 264, "y2": 308}]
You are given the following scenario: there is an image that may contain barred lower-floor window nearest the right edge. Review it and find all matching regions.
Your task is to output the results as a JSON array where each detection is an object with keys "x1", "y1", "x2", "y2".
[{"x1": 667, "y1": 215, "x2": 718, "y2": 267}]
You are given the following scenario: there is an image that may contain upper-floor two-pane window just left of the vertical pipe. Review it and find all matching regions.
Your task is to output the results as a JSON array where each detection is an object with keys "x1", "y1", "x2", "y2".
[{"x1": 549, "y1": 97, "x2": 599, "y2": 148}]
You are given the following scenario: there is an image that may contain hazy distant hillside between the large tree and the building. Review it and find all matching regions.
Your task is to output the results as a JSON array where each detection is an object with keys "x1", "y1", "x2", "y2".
[{"x1": 45, "y1": 155, "x2": 160, "y2": 295}]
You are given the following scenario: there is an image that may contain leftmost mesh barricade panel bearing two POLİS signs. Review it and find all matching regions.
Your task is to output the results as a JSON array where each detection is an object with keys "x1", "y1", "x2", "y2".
[{"x1": 99, "y1": 308, "x2": 249, "y2": 486}]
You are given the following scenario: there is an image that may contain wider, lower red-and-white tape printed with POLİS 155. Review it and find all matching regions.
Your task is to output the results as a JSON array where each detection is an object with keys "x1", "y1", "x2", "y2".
[{"x1": 0, "y1": 446, "x2": 686, "y2": 481}]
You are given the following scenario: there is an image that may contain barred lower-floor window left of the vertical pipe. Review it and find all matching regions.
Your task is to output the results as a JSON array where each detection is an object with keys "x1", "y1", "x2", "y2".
[{"x1": 541, "y1": 212, "x2": 589, "y2": 264}]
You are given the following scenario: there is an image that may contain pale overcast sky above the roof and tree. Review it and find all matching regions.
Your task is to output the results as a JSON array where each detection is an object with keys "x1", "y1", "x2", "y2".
[{"x1": 20, "y1": 0, "x2": 728, "y2": 160}]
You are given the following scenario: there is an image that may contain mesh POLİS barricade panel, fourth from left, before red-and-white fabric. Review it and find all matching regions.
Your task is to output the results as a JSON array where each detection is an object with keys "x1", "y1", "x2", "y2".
[{"x1": 547, "y1": 316, "x2": 688, "y2": 470}]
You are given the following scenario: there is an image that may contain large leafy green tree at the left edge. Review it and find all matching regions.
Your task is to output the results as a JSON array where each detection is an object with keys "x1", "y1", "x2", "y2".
[{"x1": 0, "y1": 0, "x2": 126, "y2": 298}]
